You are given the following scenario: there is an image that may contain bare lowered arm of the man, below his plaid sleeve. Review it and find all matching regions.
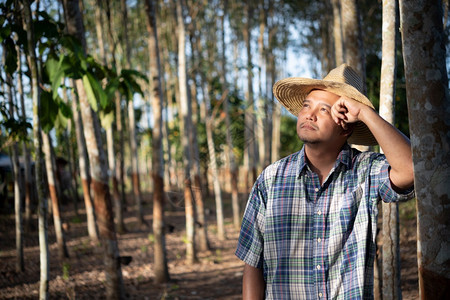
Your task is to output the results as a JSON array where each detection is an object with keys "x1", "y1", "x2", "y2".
[{"x1": 242, "y1": 264, "x2": 266, "y2": 300}]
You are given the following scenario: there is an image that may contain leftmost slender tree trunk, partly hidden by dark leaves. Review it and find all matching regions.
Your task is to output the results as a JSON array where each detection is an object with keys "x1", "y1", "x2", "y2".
[{"x1": 3, "y1": 68, "x2": 25, "y2": 272}]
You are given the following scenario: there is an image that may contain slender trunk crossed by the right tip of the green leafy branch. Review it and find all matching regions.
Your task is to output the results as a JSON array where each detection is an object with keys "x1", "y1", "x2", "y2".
[{"x1": 120, "y1": 0, "x2": 145, "y2": 226}]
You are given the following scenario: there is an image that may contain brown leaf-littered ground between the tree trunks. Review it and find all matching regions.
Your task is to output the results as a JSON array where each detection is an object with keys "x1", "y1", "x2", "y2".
[{"x1": 0, "y1": 194, "x2": 418, "y2": 299}]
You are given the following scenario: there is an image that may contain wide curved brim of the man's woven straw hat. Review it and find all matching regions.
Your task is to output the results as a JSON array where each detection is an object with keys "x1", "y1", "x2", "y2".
[{"x1": 273, "y1": 77, "x2": 378, "y2": 146}]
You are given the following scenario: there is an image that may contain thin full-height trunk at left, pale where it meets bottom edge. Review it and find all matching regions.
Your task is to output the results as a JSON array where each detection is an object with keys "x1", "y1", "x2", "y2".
[{"x1": 22, "y1": 0, "x2": 50, "y2": 300}]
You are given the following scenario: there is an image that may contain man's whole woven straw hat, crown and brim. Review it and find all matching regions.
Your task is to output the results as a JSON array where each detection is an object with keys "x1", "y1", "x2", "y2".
[{"x1": 273, "y1": 64, "x2": 378, "y2": 146}]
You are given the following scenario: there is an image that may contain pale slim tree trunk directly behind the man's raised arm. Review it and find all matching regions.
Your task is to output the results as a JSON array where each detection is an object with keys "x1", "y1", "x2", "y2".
[{"x1": 380, "y1": 0, "x2": 402, "y2": 300}]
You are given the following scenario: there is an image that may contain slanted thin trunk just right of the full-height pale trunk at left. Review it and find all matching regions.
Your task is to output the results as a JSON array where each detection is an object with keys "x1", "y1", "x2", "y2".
[{"x1": 42, "y1": 132, "x2": 69, "y2": 261}]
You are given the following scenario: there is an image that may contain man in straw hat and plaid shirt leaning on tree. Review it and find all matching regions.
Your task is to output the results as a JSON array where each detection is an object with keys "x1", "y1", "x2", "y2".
[{"x1": 236, "y1": 64, "x2": 414, "y2": 299}]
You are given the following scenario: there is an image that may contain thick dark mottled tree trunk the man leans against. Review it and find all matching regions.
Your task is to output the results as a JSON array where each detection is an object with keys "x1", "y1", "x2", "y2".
[{"x1": 400, "y1": 0, "x2": 450, "y2": 299}]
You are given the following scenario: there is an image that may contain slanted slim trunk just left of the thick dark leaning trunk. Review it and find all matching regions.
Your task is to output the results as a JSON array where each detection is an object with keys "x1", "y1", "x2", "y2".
[{"x1": 72, "y1": 81, "x2": 98, "y2": 242}]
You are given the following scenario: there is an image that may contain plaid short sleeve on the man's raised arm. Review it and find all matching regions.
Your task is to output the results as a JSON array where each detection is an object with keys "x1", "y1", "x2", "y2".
[{"x1": 370, "y1": 154, "x2": 415, "y2": 202}]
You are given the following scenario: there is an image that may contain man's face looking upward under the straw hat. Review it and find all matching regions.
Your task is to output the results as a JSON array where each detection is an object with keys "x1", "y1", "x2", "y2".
[{"x1": 297, "y1": 90, "x2": 346, "y2": 144}]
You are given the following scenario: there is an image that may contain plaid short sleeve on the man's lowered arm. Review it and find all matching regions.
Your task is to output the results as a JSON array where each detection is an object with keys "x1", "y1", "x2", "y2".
[{"x1": 235, "y1": 181, "x2": 266, "y2": 268}]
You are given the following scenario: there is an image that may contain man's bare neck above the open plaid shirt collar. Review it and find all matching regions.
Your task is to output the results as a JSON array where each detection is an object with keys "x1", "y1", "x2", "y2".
[{"x1": 305, "y1": 144, "x2": 342, "y2": 184}]
